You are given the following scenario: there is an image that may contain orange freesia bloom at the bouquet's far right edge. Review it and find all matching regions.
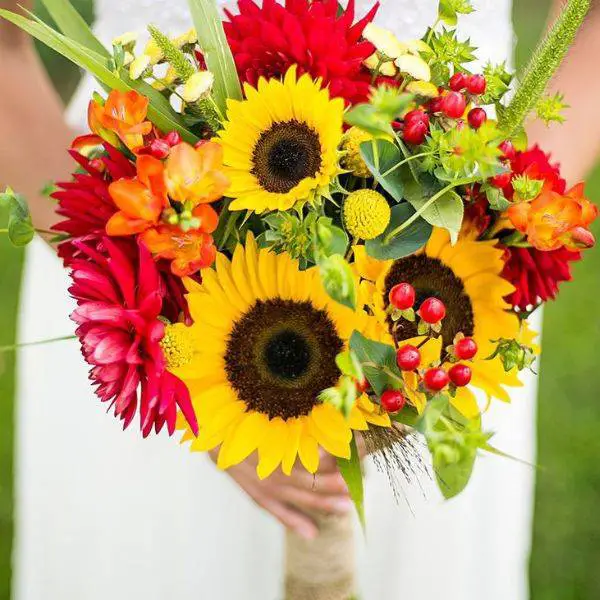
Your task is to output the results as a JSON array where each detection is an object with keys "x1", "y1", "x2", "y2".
[{"x1": 506, "y1": 183, "x2": 598, "y2": 250}]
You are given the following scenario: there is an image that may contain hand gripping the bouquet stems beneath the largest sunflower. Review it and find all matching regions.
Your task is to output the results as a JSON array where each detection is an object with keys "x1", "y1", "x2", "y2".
[{"x1": 210, "y1": 451, "x2": 352, "y2": 539}]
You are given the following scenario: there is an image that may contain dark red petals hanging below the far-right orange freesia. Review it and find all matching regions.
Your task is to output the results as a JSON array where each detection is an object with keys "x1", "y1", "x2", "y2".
[{"x1": 502, "y1": 247, "x2": 581, "y2": 310}]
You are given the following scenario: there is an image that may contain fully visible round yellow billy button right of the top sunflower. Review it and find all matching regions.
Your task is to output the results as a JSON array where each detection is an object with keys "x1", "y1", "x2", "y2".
[{"x1": 343, "y1": 189, "x2": 391, "y2": 240}]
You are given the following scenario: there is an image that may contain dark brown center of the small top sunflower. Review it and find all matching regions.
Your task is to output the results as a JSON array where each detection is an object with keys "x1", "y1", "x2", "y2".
[{"x1": 252, "y1": 119, "x2": 321, "y2": 194}]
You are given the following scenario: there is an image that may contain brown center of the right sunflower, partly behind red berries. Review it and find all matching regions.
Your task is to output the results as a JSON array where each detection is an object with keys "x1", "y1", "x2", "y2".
[{"x1": 385, "y1": 254, "x2": 474, "y2": 347}]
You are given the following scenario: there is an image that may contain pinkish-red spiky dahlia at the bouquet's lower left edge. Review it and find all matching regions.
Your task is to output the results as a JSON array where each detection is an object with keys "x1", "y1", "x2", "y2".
[{"x1": 69, "y1": 237, "x2": 198, "y2": 437}]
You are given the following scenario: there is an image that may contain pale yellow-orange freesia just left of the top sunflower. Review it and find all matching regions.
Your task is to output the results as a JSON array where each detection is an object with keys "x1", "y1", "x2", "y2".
[{"x1": 165, "y1": 142, "x2": 229, "y2": 207}]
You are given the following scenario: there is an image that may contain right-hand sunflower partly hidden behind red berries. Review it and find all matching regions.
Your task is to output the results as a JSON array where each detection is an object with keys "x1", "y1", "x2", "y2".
[{"x1": 355, "y1": 229, "x2": 534, "y2": 417}]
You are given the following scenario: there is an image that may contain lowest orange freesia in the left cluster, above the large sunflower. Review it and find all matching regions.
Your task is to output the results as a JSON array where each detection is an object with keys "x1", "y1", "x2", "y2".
[{"x1": 142, "y1": 204, "x2": 219, "y2": 277}]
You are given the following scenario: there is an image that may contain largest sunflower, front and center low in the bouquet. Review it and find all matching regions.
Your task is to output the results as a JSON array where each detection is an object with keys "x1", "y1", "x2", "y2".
[{"x1": 173, "y1": 235, "x2": 390, "y2": 477}]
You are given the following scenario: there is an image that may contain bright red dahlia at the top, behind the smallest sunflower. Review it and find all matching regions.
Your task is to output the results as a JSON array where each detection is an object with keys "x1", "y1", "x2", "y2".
[{"x1": 224, "y1": 0, "x2": 379, "y2": 104}]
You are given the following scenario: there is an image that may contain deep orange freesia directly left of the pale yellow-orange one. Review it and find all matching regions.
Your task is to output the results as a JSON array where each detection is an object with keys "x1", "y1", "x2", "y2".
[{"x1": 106, "y1": 155, "x2": 169, "y2": 235}]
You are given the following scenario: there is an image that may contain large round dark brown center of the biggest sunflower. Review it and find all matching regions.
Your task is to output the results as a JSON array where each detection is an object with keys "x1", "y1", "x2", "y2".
[{"x1": 225, "y1": 299, "x2": 343, "y2": 419}]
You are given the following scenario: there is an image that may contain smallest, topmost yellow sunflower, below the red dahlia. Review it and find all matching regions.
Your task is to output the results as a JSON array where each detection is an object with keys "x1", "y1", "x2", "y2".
[{"x1": 219, "y1": 67, "x2": 344, "y2": 213}]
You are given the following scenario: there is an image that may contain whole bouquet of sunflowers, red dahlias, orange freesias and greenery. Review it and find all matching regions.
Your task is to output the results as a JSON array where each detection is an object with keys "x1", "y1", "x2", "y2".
[{"x1": 0, "y1": 0, "x2": 597, "y2": 598}]
